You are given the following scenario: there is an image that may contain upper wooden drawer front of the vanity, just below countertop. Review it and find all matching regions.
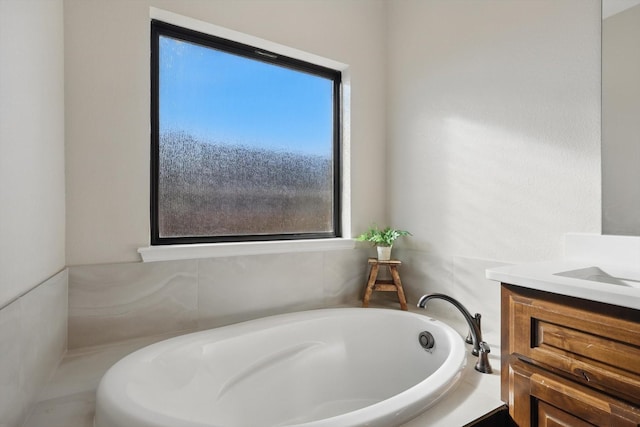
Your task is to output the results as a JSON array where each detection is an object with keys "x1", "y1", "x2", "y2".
[{"x1": 503, "y1": 289, "x2": 640, "y2": 405}]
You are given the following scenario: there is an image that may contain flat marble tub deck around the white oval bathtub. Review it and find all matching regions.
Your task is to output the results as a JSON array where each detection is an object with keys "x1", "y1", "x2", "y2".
[{"x1": 23, "y1": 298, "x2": 503, "y2": 427}]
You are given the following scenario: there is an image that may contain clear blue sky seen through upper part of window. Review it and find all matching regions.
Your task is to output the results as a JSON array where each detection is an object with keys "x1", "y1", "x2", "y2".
[{"x1": 160, "y1": 36, "x2": 333, "y2": 156}]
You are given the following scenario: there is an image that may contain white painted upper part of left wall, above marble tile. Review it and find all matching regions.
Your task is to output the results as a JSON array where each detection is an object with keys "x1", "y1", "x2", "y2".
[{"x1": 0, "y1": 0, "x2": 65, "y2": 308}]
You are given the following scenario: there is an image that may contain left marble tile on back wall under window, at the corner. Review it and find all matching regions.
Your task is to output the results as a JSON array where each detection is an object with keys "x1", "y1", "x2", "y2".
[{"x1": 69, "y1": 261, "x2": 198, "y2": 349}]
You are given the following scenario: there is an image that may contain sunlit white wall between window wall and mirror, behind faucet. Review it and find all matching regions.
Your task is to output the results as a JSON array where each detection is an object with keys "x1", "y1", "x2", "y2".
[{"x1": 388, "y1": 0, "x2": 601, "y2": 336}]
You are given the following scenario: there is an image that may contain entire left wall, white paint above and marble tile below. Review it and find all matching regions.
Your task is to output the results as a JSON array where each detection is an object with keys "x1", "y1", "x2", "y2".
[{"x1": 0, "y1": 0, "x2": 68, "y2": 427}]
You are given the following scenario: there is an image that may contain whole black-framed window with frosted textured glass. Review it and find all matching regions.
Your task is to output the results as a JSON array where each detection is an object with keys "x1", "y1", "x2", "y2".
[{"x1": 151, "y1": 21, "x2": 341, "y2": 245}]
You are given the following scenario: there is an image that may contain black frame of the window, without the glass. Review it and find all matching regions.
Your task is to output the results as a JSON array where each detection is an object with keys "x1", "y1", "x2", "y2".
[{"x1": 150, "y1": 20, "x2": 342, "y2": 245}]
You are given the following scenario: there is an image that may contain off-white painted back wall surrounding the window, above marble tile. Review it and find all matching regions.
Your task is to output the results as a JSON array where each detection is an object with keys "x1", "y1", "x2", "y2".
[{"x1": 65, "y1": 0, "x2": 386, "y2": 265}]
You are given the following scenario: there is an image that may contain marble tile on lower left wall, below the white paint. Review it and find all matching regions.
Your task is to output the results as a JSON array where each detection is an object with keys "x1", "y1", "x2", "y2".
[{"x1": 0, "y1": 270, "x2": 68, "y2": 427}]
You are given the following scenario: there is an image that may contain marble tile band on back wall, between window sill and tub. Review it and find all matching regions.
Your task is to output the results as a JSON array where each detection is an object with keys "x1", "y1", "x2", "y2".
[{"x1": 69, "y1": 250, "x2": 370, "y2": 349}]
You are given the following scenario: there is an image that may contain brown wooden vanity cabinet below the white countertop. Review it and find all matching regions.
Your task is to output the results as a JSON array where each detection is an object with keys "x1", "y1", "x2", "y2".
[{"x1": 501, "y1": 283, "x2": 640, "y2": 427}]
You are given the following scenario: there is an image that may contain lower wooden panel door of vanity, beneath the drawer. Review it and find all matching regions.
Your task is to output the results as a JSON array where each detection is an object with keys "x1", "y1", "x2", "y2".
[{"x1": 509, "y1": 358, "x2": 640, "y2": 427}]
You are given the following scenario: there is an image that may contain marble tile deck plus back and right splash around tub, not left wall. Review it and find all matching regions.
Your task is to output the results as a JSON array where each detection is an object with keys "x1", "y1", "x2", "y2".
[{"x1": 23, "y1": 249, "x2": 510, "y2": 427}]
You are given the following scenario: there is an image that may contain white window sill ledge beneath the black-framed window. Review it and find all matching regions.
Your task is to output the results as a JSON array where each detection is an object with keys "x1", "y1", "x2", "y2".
[{"x1": 138, "y1": 238, "x2": 356, "y2": 262}]
